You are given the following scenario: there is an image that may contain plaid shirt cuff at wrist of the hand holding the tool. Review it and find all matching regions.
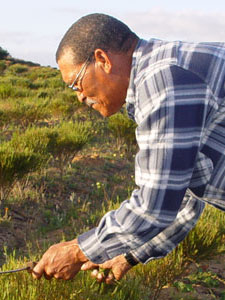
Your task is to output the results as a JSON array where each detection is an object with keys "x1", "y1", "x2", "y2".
[{"x1": 77, "y1": 228, "x2": 111, "y2": 264}]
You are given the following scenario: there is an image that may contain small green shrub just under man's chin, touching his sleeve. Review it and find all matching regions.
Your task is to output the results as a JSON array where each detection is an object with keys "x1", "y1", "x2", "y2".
[{"x1": 108, "y1": 113, "x2": 137, "y2": 150}]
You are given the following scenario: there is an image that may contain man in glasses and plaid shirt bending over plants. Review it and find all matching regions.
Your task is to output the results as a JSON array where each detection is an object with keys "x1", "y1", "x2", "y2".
[{"x1": 33, "y1": 14, "x2": 225, "y2": 283}]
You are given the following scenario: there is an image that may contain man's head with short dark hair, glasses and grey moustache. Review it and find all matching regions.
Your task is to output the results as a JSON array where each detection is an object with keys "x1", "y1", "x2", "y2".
[{"x1": 56, "y1": 14, "x2": 138, "y2": 116}]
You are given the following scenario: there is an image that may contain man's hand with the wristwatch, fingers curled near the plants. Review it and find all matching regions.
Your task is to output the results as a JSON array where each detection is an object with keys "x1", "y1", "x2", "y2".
[{"x1": 81, "y1": 255, "x2": 132, "y2": 284}]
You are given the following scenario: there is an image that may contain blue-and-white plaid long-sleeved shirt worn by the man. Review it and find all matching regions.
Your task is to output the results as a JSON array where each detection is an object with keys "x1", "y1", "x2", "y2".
[{"x1": 78, "y1": 39, "x2": 225, "y2": 263}]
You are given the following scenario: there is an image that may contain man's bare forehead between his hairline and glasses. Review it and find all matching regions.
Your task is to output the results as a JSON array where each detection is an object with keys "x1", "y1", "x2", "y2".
[{"x1": 58, "y1": 49, "x2": 80, "y2": 83}]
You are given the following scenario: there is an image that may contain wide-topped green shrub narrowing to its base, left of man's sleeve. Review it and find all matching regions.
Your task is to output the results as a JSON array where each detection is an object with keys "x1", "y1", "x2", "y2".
[{"x1": 10, "y1": 122, "x2": 91, "y2": 175}]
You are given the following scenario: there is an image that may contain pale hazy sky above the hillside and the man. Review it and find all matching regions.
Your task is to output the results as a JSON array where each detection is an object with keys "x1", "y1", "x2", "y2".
[{"x1": 0, "y1": 0, "x2": 225, "y2": 67}]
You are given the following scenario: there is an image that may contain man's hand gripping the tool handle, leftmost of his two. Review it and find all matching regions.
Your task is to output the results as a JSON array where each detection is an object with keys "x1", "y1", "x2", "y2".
[{"x1": 32, "y1": 239, "x2": 88, "y2": 280}]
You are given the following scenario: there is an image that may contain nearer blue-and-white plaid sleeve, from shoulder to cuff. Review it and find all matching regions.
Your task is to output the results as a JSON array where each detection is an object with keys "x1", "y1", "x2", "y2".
[{"x1": 78, "y1": 65, "x2": 208, "y2": 263}]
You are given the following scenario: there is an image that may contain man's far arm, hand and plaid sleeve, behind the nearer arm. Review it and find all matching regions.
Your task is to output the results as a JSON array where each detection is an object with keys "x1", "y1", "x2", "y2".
[{"x1": 81, "y1": 193, "x2": 205, "y2": 284}]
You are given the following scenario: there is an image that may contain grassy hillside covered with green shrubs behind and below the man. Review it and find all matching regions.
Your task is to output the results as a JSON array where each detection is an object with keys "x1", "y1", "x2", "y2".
[{"x1": 0, "y1": 55, "x2": 225, "y2": 300}]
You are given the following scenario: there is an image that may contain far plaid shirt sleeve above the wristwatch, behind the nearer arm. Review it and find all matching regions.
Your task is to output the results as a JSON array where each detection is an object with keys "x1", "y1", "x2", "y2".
[{"x1": 131, "y1": 193, "x2": 205, "y2": 264}]
